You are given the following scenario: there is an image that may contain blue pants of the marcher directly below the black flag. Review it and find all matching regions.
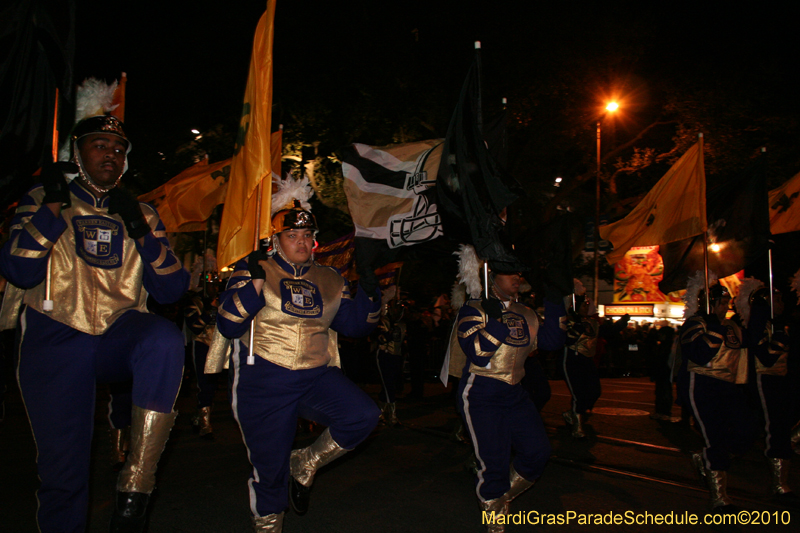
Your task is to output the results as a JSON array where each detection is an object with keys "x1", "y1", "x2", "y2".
[{"x1": 458, "y1": 372, "x2": 551, "y2": 501}]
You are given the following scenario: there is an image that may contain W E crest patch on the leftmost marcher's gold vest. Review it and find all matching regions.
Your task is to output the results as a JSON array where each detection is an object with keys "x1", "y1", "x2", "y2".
[{"x1": 72, "y1": 216, "x2": 125, "y2": 269}]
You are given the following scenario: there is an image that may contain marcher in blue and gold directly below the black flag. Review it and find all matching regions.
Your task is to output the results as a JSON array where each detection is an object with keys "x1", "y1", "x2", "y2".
[{"x1": 450, "y1": 271, "x2": 551, "y2": 532}]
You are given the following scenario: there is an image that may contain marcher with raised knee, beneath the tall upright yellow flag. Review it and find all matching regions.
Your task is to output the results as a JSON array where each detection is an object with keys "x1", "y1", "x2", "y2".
[{"x1": 217, "y1": 203, "x2": 380, "y2": 532}]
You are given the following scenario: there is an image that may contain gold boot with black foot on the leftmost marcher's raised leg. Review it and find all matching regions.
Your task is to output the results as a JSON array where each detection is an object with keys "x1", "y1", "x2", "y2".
[{"x1": 111, "y1": 405, "x2": 178, "y2": 533}]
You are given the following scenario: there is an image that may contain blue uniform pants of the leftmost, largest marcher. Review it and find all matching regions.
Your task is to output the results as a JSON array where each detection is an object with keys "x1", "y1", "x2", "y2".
[{"x1": 18, "y1": 308, "x2": 183, "y2": 533}]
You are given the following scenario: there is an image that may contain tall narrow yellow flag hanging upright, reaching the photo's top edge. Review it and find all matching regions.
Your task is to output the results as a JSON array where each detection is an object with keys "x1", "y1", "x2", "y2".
[{"x1": 217, "y1": 0, "x2": 275, "y2": 268}]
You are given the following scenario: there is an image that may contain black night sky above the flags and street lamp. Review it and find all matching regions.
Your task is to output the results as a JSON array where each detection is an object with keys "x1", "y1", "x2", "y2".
[{"x1": 75, "y1": 0, "x2": 798, "y2": 179}]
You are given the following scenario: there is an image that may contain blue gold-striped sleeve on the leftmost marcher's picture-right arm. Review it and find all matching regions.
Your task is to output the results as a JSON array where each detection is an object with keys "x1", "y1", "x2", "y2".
[{"x1": 134, "y1": 204, "x2": 189, "y2": 304}]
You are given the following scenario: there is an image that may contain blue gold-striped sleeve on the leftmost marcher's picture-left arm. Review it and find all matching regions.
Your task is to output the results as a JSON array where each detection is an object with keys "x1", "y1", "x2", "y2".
[{"x1": 0, "y1": 186, "x2": 67, "y2": 289}]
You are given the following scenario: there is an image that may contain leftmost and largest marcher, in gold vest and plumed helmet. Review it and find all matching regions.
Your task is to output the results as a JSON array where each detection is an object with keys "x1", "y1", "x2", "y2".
[{"x1": 0, "y1": 115, "x2": 189, "y2": 533}]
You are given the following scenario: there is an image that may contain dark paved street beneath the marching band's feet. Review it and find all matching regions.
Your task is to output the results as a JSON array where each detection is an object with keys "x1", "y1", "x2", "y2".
[{"x1": 0, "y1": 372, "x2": 800, "y2": 533}]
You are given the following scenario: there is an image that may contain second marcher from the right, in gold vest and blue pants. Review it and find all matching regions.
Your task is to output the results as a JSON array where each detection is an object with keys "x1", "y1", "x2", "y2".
[{"x1": 680, "y1": 284, "x2": 764, "y2": 513}]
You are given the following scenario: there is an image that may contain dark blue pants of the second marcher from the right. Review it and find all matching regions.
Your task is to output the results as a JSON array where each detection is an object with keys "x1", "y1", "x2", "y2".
[{"x1": 689, "y1": 372, "x2": 756, "y2": 471}]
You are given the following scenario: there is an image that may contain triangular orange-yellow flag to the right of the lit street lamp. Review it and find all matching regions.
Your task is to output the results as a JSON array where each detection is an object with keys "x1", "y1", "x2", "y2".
[{"x1": 600, "y1": 138, "x2": 707, "y2": 265}]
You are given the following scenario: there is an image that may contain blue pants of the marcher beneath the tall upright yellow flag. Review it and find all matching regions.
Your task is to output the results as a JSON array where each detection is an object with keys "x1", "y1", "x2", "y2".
[{"x1": 231, "y1": 345, "x2": 380, "y2": 516}]
